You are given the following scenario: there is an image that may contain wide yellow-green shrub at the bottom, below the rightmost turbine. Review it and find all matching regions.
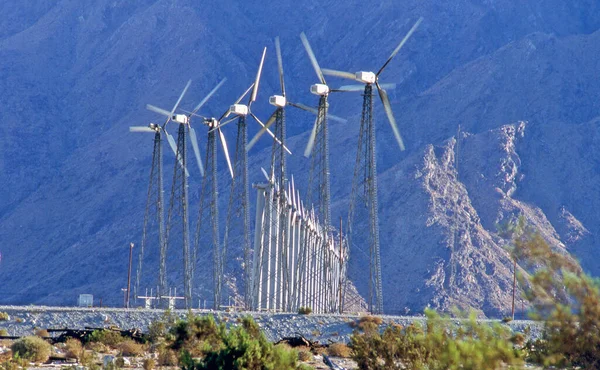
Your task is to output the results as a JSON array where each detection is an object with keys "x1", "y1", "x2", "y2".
[{"x1": 351, "y1": 310, "x2": 522, "y2": 370}]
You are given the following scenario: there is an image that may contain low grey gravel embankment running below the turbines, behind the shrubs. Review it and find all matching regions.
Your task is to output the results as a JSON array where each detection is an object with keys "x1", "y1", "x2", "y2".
[{"x1": 0, "y1": 306, "x2": 542, "y2": 343}]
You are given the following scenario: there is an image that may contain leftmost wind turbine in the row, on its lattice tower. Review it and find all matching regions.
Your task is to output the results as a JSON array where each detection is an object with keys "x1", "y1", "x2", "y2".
[{"x1": 129, "y1": 123, "x2": 165, "y2": 304}]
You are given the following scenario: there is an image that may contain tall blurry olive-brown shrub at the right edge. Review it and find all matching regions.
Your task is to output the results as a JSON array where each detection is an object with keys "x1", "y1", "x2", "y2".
[{"x1": 513, "y1": 230, "x2": 600, "y2": 369}]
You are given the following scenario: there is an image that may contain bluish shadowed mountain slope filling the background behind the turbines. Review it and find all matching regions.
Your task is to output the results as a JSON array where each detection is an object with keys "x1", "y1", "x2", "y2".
[{"x1": 0, "y1": 0, "x2": 600, "y2": 316}]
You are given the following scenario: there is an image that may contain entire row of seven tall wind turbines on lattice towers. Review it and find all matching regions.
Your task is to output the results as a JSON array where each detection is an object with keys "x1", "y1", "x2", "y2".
[{"x1": 130, "y1": 18, "x2": 422, "y2": 313}]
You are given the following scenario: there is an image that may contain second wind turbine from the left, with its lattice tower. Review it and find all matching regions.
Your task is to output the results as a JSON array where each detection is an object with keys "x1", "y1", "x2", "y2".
[{"x1": 146, "y1": 80, "x2": 209, "y2": 308}]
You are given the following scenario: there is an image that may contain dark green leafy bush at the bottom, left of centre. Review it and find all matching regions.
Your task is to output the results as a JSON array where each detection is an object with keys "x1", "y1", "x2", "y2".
[{"x1": 171, "y1": 316, "x2": 298, "y2": 370}]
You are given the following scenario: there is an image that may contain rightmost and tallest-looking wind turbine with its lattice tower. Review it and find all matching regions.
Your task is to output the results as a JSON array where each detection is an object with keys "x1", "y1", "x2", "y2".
[{"x1": 323, "y1": 18, "x2": 423, "y2": 314}]
